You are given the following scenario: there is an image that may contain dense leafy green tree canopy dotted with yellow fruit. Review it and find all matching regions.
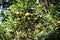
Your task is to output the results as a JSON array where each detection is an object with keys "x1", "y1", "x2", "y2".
[{"x1": 0, "y1": 0, "x2": 60, "y2": 40}]
